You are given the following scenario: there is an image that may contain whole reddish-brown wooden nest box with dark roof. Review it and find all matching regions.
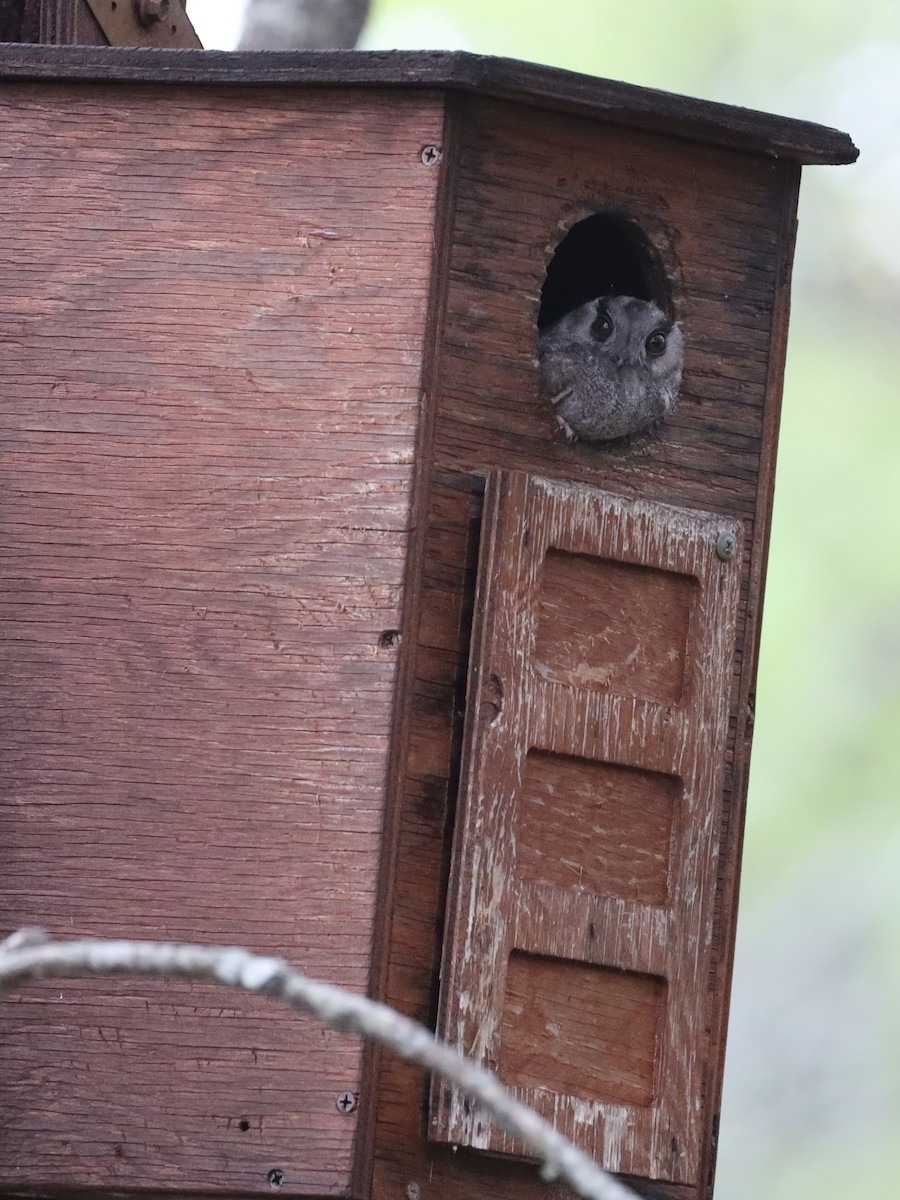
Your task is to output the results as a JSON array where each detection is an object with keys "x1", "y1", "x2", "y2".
[{"x1": 0, "y1": 46, "x2": 856, "y2": 1200}]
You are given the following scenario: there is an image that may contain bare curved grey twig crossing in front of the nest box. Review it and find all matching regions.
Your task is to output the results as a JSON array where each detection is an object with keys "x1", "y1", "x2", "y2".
[{"x1": 0, "y1": 929, "x2": 637, "y2": 1200}]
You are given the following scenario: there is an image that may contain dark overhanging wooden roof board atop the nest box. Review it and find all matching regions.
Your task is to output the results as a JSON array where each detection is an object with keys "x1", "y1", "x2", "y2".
[{"x1": 0, "y1": 43, "x2": 858, "y2": 164}]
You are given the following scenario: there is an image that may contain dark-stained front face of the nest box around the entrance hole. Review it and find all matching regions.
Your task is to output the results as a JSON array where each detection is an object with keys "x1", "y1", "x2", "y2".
[{"x1": 373, "y1": 98, "x2": 799, "y2": 1200}]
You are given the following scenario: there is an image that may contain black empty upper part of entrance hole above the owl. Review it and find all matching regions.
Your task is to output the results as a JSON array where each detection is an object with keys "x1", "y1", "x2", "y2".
[{"x1": 538, "y1": 212, "x2": 673, "y2": 329}]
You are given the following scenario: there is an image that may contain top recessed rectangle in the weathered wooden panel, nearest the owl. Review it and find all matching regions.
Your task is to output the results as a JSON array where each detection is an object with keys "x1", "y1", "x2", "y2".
[{"x1": 533, "y1": 547, "x2": 697, "y2": 703}]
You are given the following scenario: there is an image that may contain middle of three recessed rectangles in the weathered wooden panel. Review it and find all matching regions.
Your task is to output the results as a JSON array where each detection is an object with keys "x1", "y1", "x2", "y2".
[{"x1": 516, "y1": 750, "x2": 682, "y2": 904}]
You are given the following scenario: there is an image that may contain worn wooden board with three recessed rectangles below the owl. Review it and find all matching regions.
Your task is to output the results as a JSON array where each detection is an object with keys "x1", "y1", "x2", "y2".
[{"x1": 431, "y1": 473, "x2": 742, "y2": 1183}]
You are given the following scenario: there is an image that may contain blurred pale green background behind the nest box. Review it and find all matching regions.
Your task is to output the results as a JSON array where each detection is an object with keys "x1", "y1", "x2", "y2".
[{"x1": 188, "y1": 0, "x2": 900, "y2": 1200}]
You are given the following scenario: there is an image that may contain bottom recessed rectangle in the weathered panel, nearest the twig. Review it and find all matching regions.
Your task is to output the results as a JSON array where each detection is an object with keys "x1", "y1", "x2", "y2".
[{"x1": 499, "y1": 950, "x2": 666, "y2": 1106}]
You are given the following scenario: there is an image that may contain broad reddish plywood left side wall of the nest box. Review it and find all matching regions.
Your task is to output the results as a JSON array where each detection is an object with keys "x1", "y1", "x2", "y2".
[{"x1": 0, "y1": 83, "x2": 443, "y2": 1195}]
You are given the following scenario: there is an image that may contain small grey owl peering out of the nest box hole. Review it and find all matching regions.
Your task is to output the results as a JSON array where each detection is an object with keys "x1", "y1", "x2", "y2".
[{"x1": 538, "y1": 296, "x2": 684, "y2": 442}]
